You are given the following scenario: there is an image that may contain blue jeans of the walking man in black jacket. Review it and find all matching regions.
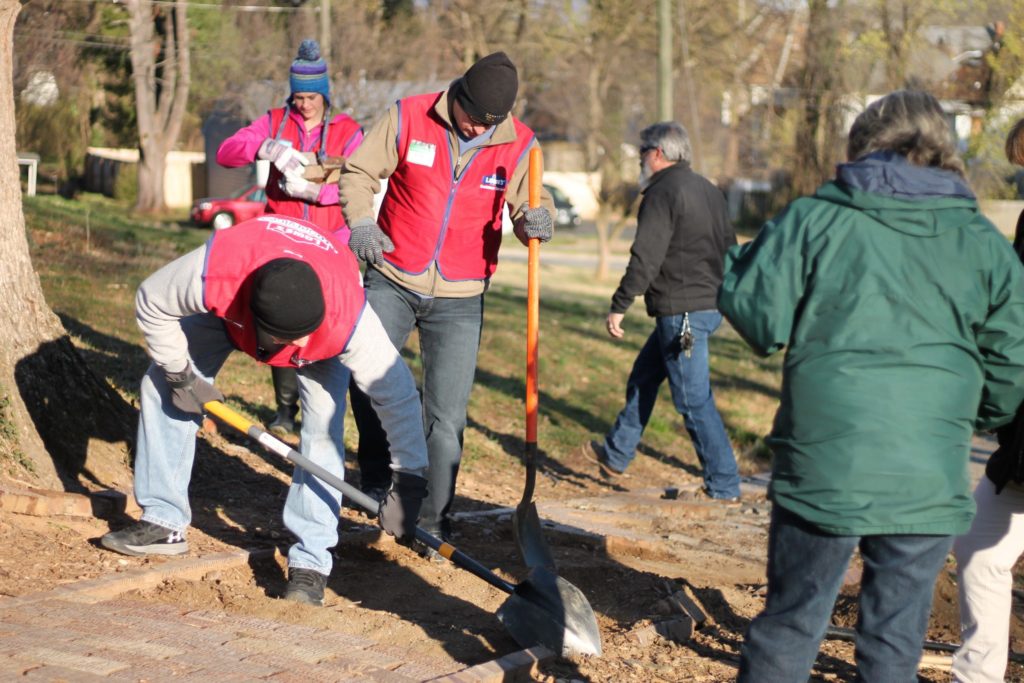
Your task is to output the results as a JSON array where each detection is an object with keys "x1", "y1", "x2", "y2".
[{"x1": 604, "y1": 310, "x2": 739, "y2": 498}]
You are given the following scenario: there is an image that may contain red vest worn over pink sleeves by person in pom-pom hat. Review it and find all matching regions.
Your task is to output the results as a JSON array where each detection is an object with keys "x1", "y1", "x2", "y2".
[{"x1": 266, "y1": 108, "x2": 362, "y2": 231}]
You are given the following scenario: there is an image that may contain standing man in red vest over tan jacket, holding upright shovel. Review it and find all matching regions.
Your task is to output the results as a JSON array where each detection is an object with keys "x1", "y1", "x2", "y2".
[{"x1": 340, "y1": 52, "x2": 554, "y2": 552}]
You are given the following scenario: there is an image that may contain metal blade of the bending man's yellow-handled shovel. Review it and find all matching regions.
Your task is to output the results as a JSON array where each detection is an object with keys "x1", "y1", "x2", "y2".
[{"x1": 498, "y1": 567, "x2": 601, "y2": 656}]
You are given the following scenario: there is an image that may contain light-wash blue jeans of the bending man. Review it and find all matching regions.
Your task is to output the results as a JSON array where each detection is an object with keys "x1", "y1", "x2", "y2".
[{"x1": 134, "y1": 314, "x2": 348, "y2": 574}]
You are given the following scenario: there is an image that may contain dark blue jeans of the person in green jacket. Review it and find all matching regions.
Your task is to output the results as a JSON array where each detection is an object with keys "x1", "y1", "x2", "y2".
[{"x1": 737, "y1": 505, "x2": 953, "y2": 683}]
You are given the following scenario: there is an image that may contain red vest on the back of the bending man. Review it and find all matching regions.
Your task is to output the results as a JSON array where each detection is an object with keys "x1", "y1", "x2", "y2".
[{"x1": 203, "y1": 215, "x2": 366, "y2": 368}]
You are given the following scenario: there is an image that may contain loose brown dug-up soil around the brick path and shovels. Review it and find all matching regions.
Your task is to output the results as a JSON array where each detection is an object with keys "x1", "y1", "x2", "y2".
[{"x1": 0, "y1": 423, "x2": 1024, "y2": 683}]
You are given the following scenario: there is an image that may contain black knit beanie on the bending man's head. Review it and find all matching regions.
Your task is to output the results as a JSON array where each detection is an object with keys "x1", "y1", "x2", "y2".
[{"x1": 249, "y1": 258, "x2": 325, "y2": 341}]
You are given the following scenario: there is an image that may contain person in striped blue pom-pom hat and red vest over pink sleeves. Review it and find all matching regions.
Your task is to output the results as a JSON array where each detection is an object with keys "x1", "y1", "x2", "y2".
[{"x1": 217, "y1": 39, "x2": 362, "y2": 434}]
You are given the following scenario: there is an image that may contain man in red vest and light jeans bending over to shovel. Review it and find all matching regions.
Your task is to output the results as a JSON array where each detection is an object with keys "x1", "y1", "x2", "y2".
[{"x1": 100, "y1": 215, "x2": 427, "y2": 605}]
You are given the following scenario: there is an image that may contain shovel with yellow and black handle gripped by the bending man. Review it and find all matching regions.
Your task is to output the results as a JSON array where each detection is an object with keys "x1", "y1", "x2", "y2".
[{"x1": 203, "y1": 400, "x2": 601, "y2": 656}]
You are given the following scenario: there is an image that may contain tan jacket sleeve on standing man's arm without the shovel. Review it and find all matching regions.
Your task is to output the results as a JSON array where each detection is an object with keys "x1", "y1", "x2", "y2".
[{"x1": 338, "y1": 104, "x2": 398, "y2": 225}]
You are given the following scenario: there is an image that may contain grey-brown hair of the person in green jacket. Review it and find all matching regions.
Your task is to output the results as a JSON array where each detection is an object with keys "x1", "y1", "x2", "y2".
[{"x1": 846, "y1": 90, "x2": 964, "y2": 176}]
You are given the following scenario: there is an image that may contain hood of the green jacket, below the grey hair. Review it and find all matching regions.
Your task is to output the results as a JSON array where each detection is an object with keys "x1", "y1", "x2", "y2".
[{"x1": 814, "y1": 152, "x2": 978, "y2": 238}]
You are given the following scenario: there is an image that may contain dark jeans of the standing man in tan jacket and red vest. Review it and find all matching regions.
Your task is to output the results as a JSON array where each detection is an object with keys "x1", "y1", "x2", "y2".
[{"x1": 350, "y1": 267, "x2": 483, "y2": 537}]
